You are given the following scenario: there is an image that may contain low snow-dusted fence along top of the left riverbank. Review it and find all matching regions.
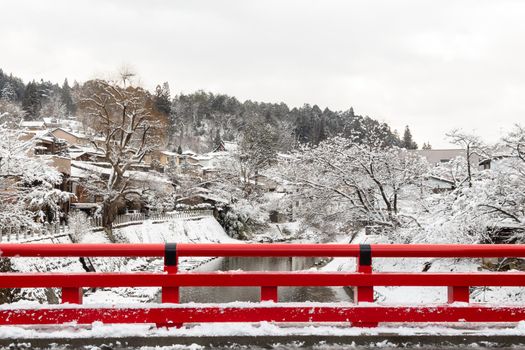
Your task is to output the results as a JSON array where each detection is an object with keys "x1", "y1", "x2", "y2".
[{"x1": 0, "y1": 209, "x2": 213, "y2": 242}]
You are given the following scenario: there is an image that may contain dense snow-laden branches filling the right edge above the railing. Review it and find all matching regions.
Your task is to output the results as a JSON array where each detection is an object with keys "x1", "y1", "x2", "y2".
[{"x1": 406, "y1": 126, "x2": 525, "y2": 243}]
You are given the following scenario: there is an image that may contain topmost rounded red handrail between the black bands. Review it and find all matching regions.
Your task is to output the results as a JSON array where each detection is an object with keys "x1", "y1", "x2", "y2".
[{"x1": 0, "y1": 243, "x2": 525, "y2": 258}]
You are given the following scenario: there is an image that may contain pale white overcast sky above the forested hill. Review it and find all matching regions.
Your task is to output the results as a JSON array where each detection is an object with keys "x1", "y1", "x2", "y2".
[{"x1": 0, "y1": 0, "x2": 525, "y2": 148}]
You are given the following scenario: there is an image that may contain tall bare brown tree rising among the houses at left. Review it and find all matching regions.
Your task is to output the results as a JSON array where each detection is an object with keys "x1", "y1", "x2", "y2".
[{"x1": 77, "y1": 76, "x2": 163, "y2": 237}]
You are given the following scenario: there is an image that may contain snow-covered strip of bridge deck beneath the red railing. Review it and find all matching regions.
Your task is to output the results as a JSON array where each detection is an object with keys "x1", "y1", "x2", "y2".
[{"x1": 0, "y1": 323, "x2": 525, "y2": 350}]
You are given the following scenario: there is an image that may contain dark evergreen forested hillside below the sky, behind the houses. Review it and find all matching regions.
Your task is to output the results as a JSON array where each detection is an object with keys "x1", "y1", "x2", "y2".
[{"x1": 0, "y1": 69, "x2": 417, "y2": 152}]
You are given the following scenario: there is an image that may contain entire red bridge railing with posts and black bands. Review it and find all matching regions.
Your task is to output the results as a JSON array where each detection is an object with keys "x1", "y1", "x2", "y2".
[{"x1": 0, "y1": 243, "x2": 525, "y2": 327}]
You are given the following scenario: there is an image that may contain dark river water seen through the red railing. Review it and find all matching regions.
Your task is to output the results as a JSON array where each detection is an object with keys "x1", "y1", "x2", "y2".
[{"x1": 176, "y1": 257, "x2": 351, "y2": 303}]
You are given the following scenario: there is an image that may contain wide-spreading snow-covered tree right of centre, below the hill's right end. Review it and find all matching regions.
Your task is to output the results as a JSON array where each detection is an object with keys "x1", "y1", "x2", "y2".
[{"x1": 276, "y1": 137, "x2": 428, "y2": 234}]
